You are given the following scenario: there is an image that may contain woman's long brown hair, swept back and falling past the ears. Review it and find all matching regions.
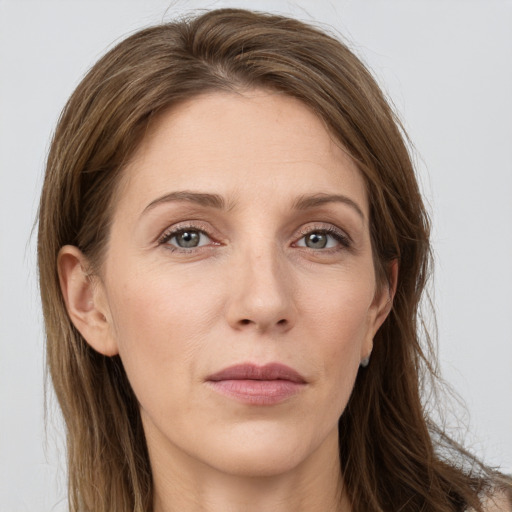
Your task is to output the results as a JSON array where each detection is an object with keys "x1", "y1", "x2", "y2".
[{"x1": 38, "y1": 9, "x2": 504, "y2": 512}]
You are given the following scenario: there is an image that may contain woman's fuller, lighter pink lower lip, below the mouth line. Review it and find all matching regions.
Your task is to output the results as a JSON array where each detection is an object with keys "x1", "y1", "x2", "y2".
[{"x1": 208, "y1": 380, "x2": 305, "y2": 405}]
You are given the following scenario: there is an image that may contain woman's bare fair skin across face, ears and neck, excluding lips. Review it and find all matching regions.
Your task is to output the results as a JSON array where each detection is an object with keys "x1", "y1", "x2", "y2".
[{"x1": 59, "y1": 90, "x2": 396, "y2": 512}]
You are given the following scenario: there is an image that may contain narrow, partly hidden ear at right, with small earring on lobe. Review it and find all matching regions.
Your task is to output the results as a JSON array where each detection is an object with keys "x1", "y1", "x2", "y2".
[{"x1": 361, "y1": 259, "x2": 398, "y2": 359}]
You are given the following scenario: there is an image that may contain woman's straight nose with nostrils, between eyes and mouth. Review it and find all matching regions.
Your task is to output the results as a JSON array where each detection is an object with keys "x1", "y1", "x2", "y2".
[{"x1": 226, "y1": 248, "x2": 297, "y2": 334}]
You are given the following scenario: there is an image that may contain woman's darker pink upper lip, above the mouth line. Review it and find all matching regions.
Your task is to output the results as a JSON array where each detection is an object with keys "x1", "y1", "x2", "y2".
[{"x1": 206, "y1": 363, "x2": 306, "y2": 384}]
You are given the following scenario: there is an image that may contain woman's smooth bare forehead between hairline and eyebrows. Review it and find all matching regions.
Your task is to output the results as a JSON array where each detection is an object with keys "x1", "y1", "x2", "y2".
[{"x1": 119, "y1": 89, "x2": 368, "y2": 213}]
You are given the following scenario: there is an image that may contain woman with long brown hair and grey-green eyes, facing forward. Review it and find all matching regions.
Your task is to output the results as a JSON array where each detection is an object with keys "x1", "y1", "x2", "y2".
[{"x1": 38, "y1": 10, "x2": 507, "y2": 512}]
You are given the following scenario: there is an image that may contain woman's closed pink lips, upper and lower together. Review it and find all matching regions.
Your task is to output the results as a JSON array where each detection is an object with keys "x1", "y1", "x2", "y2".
[{"x1": 206, "y1": 363, "x2": 306, "y2": 405}]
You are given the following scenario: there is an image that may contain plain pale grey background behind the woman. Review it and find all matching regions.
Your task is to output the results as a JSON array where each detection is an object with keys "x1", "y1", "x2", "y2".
[{"x1": 0, "y1": 0, "x2": 512, "y2": 512}]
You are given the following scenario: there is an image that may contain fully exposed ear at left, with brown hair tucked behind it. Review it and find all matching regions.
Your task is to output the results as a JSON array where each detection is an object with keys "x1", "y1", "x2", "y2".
[{"x1": 57, "y1": 245, "x2": 118, "y2": 356}]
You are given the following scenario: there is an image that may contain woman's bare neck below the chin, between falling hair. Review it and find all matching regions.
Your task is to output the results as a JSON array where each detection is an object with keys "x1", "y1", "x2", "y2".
[{"x1": 148, "y1": 426, "x2": 351, "y2": 512}]
